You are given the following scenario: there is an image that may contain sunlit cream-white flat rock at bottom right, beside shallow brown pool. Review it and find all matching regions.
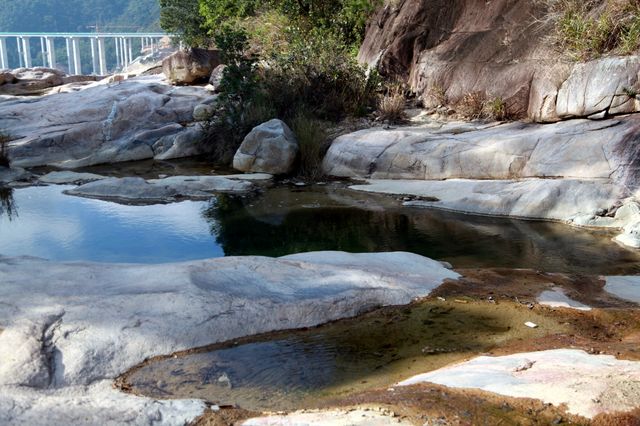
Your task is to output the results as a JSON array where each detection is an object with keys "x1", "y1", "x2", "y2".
[{"x1": 399, "y1": 349, "x2": 640, "y2": 418}]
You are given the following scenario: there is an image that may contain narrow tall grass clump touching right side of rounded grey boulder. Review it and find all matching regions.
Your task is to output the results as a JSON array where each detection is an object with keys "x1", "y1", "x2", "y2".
[{"x1": 291, "y1": 113, "x2": 329, "y2": 181}]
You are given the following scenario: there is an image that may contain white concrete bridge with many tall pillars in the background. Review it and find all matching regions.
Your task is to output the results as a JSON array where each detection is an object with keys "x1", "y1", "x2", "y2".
[{"x1": 0, "y1": 32, "x2": 167, "y2": 75}]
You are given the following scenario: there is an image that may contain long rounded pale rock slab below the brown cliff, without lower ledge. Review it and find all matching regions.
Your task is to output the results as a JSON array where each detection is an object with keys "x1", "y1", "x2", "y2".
[{"x1": 323, "y1": 116, "x2": 640, "y2": 185}]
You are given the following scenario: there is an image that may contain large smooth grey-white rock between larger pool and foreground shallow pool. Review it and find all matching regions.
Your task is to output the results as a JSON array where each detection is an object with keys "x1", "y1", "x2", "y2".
[{"x1": 0, "y1": 252, "x2": 458, "y2": 425}]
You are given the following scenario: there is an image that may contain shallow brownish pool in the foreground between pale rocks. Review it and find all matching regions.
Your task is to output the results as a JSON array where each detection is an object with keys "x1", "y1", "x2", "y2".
[{"x1": 126, "y1": 302, "x2": 565, "y2": 410}]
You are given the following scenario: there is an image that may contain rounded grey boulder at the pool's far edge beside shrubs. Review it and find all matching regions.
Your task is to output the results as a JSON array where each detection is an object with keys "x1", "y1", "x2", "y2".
[{"x1": 233, "y1": 119, "x2": 299, "y2": 175}]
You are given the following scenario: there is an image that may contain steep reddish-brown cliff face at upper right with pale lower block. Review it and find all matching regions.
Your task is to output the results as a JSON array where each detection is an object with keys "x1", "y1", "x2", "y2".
[{"x1": 359, "y1": 0, "x2": 640, "y2": 122}]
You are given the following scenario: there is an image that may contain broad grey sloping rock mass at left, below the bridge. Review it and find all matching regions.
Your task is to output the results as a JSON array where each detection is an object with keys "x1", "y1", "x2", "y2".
[{"x1": 0, "y1": 76, "x2": 210, "y2": 168}]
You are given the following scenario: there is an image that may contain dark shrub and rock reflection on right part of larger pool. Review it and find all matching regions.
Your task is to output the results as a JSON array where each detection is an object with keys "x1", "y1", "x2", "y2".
[{"x1": 205, "y1": 188, "x2": 640, "y2": 274}]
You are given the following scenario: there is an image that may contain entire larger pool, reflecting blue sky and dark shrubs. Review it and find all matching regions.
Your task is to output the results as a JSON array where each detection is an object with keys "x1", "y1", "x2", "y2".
[{"x1": 0, "y1": 185, "x2": 640, "y2": 274}]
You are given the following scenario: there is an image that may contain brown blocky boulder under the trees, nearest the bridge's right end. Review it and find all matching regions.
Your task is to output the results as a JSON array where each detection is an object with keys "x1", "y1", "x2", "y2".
[{"x1": 162, "y1": 48, "x2": 220, "y2": 84}]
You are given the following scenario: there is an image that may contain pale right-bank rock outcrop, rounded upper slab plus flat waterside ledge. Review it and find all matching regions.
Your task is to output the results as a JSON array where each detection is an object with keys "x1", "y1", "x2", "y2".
[{"x1": 323, "y1": 115, "x2": 640, "y2": 247}]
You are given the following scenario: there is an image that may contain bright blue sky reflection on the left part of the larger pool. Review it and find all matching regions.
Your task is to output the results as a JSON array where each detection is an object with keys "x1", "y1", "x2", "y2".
[{"x1": 0, "y1": 186, "x2": 224, "y2": 263}]
